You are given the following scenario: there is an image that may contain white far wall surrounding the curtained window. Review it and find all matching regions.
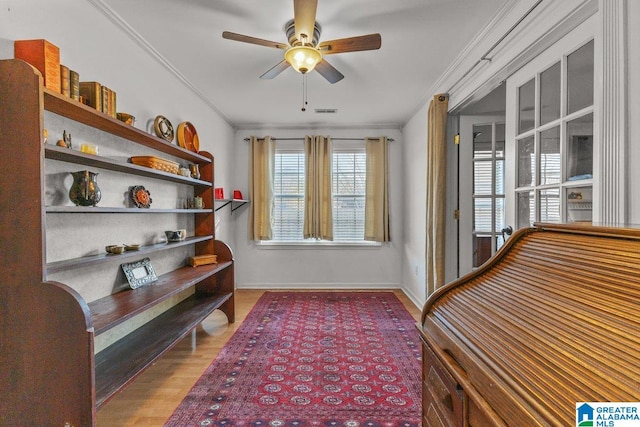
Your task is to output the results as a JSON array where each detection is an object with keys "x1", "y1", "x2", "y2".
[{"x1": 231, "y1": 127, "x2": 404, "y2": 289}]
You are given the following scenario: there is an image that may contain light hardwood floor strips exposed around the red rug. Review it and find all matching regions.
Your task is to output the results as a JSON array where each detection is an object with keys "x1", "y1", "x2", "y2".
[{"x1": 96, "y1": 290, "x2": 420, "y2": 427}]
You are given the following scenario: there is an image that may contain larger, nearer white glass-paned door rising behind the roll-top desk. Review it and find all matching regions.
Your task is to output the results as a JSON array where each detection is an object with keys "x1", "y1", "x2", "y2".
[{"x1": 507, "y1": 34, "x2": 594, "y2": 228}]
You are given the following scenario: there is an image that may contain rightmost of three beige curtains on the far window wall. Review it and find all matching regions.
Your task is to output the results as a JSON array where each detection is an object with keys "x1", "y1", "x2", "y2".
[{"x1": 364, "y1": 136, "x2": 391, "y2": 242}]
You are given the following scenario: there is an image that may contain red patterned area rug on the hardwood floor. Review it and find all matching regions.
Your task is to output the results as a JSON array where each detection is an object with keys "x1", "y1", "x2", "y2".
[{"x1": 166, "y1": 292, "x2": 421, "y2": 427}]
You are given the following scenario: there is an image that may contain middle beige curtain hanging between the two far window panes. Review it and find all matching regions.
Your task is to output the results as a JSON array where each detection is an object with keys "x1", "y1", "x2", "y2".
[{"x1": 304, "y1": 136, "x2": 333, "y2": 240}]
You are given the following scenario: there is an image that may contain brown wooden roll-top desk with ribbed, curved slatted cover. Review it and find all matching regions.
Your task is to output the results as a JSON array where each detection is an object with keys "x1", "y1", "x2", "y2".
[{"x1": 418, "y1": 224, "x2": 640, "y2": 427}]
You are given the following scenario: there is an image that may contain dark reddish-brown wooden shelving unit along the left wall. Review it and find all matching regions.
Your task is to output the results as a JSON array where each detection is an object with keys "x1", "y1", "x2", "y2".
[{"x1": 0, "y1": 60, "x2": 235, "y2": 426}]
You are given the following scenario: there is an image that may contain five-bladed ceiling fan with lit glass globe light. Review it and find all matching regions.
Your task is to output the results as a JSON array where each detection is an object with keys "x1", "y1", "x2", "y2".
[{"x1": 222, "y1": 0, "x2": 382, "y2": 83}]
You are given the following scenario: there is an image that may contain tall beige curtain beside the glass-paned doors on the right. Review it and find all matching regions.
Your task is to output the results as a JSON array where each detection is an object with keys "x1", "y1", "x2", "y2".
[{"x1": 426, "y1": 94, "x2": 449, "y2": 296}]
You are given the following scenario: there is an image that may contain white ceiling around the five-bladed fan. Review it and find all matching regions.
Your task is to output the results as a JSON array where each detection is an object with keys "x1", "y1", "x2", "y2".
[{"x1": 102, "y1": 0, "x2": 505, "y2": 129}]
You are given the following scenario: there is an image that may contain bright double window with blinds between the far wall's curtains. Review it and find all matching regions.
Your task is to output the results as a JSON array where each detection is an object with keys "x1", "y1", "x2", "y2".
[{"x1": 273, "y1": 147, "x2": 366, "y2": 242}]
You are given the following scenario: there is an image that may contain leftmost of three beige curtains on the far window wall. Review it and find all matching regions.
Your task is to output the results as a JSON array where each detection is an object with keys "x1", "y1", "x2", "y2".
[{"x1": 249, "y1": 136, "x2": 276, "y2": 240}]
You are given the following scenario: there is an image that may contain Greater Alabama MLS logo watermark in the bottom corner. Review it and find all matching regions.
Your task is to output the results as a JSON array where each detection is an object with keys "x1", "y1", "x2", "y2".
[{"x1": 576, "y1": 402, "x2": 640, "y2": 427}]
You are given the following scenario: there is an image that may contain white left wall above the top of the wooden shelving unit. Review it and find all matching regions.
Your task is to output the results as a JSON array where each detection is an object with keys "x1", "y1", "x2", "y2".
[{"x1": 0, "y1": 0, "x2": 233, "y2": 247}]
